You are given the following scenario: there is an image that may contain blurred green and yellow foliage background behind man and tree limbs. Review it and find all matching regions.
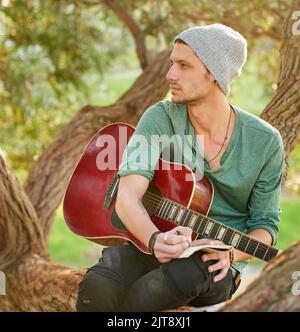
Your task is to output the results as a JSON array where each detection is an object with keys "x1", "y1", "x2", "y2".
[{"x1": 0, "y1": 0, "x2": 300, "y2": 266}]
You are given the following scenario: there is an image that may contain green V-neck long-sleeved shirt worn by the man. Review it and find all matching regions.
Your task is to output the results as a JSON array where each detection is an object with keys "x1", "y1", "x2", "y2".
[{"x1": 119, "y1": 101, "x2": 284, "y2": 270}]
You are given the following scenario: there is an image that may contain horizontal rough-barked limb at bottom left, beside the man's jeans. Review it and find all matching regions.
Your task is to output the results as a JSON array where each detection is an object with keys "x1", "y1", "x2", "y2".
[{"x1": 0, "y1": 254, "x2": 85, "y2": 312}]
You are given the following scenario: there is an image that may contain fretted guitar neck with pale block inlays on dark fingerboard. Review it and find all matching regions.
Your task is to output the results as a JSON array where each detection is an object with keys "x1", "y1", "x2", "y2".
[{"x1": 150, "y1": 198, "x2": 278, "y2": 261}]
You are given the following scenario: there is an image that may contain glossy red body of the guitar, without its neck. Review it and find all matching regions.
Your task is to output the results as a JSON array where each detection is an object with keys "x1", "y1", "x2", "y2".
[{"x1": 63, "y1": 123, "x2": 213, "y2": 253}]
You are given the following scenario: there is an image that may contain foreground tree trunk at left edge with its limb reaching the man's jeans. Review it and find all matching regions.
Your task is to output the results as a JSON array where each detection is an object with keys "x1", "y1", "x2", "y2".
[{"x1": 0, "y1": 155, "x2": 84, "y2": 311}]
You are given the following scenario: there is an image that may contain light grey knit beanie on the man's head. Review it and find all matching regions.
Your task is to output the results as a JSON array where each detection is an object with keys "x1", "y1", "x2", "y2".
[{"x1": 175, "y1": 23, "x2": 247, "y2": 96}]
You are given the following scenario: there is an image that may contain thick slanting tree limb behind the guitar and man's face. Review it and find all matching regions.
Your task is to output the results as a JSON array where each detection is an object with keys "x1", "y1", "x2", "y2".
[{"x1": 25, "y1": 50, "x2": 170, "y2": 237}]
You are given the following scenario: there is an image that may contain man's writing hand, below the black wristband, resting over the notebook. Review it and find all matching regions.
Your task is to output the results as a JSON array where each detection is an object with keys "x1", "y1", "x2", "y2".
[{"x1": 154, "y1": 226, "x2": 193, "y2": 263}]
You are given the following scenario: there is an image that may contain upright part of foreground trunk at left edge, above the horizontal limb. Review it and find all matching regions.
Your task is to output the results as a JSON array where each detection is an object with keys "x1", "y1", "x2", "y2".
[{"x1": 0, "y1": 154, "x2": 47, "y2": 270}]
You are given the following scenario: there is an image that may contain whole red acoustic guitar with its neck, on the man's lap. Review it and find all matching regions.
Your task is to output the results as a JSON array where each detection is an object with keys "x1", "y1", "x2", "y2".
[{"x1": 63, "y1": 123, "x2": 279, "y2": 261}]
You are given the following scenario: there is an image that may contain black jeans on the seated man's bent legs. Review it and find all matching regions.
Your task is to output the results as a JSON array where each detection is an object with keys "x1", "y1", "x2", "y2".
[{"x1": 76, "y1": 244, "x2": 236, "y2": 312}]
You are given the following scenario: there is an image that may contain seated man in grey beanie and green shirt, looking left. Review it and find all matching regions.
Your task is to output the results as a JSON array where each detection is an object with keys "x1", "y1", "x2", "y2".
[{"x1": 77, "y1": 24, "x2": 284, "y2": 311}]
